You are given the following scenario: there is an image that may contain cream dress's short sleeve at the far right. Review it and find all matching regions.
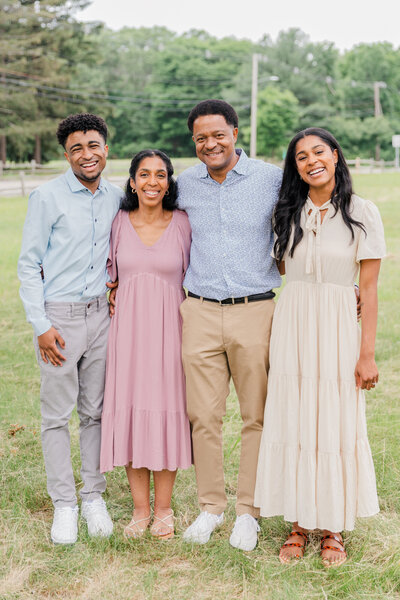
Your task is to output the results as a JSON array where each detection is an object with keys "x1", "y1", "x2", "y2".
[{"x1": 356, "y1": 200, "x2": 386, "y2": 262}]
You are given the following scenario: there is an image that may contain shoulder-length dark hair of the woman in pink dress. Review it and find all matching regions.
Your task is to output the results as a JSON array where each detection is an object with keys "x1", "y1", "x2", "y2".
[{"x1": 121, "y1": 149, "x2": 177, "y2": 211}]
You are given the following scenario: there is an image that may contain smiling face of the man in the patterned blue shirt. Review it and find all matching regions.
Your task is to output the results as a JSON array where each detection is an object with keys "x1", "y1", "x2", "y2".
[{"x1": 193, "y1": 115, "x2": 238, "y2": 176}]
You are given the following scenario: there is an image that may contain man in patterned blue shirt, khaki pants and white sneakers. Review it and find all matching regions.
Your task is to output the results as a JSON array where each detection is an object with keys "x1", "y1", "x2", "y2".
[{"x1": 178, "y1": 100, "x2": 282, "y2": 550}]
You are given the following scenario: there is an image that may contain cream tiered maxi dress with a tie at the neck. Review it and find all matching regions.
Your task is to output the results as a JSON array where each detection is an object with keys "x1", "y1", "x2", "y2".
[{"x1": 254, "y1": 196, "x2": 385, "y2": 531}]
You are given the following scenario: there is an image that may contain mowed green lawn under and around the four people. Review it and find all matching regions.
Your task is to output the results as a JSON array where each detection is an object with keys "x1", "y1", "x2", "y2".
[{"x1": 0, "y1": 173, "x2": 400, "y2": 600}]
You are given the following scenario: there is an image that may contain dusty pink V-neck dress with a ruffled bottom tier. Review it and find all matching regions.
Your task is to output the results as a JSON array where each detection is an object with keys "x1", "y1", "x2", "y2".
[{"x1": 100, "y1": 210, "x2": 192, "y2": 472}]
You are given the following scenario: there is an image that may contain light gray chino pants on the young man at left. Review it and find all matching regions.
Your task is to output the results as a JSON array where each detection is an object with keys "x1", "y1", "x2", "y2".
[{"x1": 34, "y1": 296, "x2": 110, "y2": 507}]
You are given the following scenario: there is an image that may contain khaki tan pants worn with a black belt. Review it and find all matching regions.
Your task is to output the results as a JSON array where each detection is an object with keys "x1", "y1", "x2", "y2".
[{"x1": 181, "y1": 297, "x2": 275, "y2": 517}]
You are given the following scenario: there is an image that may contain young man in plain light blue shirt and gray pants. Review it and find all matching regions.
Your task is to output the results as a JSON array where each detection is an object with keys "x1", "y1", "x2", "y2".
[{"x1": 18, "y1": 113, "x2": 122, "y2": 544}]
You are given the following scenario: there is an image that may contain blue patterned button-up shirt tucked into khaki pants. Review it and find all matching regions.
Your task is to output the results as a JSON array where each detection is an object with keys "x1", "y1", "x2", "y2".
[{"x1": 178, "y1": 150, "x2": 282, "y2": 300}]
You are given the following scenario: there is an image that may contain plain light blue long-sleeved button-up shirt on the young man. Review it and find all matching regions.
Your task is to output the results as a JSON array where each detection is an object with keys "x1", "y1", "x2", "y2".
[{"x1": 18, "y1": 169, "x2": 123, "y2": 335}]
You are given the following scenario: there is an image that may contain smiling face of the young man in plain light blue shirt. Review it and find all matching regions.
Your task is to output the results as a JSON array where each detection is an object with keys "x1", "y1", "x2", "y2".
[{"x1": 64, "y1": 130, "x2": 108, "y2": 191}]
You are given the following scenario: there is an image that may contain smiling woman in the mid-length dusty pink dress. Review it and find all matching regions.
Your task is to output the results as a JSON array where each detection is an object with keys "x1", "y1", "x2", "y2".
[{"x1": 101, "y1": 150, "x2": 192, "y2": 539}]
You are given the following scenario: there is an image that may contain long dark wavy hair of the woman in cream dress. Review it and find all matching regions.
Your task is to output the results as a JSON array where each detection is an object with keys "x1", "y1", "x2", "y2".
[{"x1": 273, "y1": 127, "x2": 365, "y2": 262}]
